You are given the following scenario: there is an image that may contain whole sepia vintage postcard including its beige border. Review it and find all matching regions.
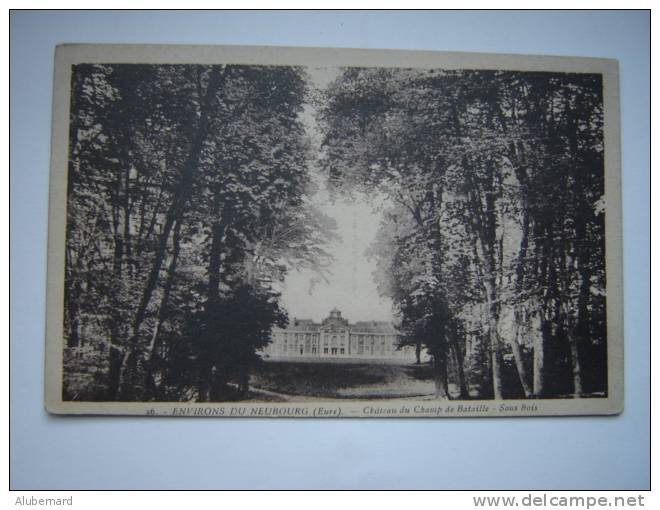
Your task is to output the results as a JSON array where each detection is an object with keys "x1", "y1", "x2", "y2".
[{"x1": 45, "y1": 45, "x2": 623, "y2": 417}]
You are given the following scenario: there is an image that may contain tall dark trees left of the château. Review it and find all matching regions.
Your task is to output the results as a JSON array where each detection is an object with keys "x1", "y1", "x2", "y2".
[{"x1": 63, "y1": 64, "x2": 333, "y2": 401}]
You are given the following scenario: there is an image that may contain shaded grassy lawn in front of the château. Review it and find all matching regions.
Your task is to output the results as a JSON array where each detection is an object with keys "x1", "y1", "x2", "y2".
[{"x1": 250, "y1": 361, "x2": 433, "y2": 398}]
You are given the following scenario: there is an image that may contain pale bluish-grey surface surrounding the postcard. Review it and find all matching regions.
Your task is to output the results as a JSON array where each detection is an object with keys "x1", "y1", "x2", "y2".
[{"x1": 10, "y1": 11, "x2": 650, "y2": 489}]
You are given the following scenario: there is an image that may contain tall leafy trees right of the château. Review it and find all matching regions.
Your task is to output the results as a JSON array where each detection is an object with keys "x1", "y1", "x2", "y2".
[{"x1": 318, "y1": 68, "x2": 607, "y2": 399}]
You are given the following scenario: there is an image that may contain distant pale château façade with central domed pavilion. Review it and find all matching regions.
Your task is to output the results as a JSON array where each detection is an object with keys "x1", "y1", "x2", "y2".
[{"x1": 261, "y1": 308, "x2": 415, "y2": 362}]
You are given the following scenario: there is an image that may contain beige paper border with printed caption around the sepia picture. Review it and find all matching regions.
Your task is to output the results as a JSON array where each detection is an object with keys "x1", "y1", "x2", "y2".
[{"x1": 44, "y1": 44, "x2": 624, "y2": 418}]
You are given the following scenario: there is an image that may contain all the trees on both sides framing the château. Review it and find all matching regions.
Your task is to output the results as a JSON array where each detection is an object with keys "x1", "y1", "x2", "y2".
[{"x1": 63, "y1": 64, "x2": 608, "y2": 402}]
